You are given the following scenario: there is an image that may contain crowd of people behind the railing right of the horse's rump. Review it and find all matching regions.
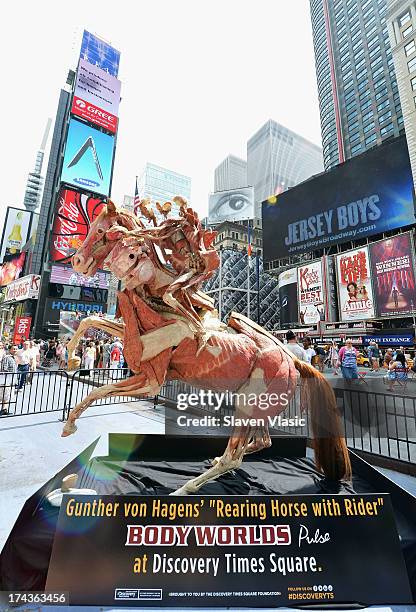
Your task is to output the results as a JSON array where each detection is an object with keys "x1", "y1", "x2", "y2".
[{"x1": 286, "y1": 330, "x2": 416, "y2": 391}]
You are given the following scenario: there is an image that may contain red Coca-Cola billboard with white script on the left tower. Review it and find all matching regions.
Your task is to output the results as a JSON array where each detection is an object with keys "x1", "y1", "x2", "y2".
[{"x1": 50, "y1": 189, "x2": 106, "y2": 263}]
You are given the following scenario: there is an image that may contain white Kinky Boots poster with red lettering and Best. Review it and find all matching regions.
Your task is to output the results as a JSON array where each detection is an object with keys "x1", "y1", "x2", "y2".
[{"x1": 298, "y1": 261, "x2": 325, "y2": 325}]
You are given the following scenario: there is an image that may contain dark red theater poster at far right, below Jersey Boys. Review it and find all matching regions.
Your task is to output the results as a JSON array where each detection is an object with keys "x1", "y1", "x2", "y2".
[{"x1": 370, "y1": 233, "x2": 416, "y2": 317}]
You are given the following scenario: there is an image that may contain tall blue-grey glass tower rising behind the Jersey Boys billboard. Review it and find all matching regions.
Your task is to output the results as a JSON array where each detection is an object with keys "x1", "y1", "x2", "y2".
[{"x1": 310, "y1": 0, "x2": 404, "y2": 170}]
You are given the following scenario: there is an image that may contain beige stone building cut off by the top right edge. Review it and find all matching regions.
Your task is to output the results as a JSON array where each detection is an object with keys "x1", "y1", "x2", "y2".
[{"x1": 387, "y1": 0, "x2": 416, "y2": 185}]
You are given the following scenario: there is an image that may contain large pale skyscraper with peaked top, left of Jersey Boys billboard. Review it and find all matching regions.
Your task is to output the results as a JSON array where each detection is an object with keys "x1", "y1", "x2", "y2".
[{"x1": 247, "y1": 119, "x2": 323, "y2": 219}]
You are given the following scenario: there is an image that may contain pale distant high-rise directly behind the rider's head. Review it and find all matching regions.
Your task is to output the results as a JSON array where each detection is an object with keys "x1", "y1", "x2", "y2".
[{"x1": 138, "y1": 163, "x2": 191, "y2": 221}]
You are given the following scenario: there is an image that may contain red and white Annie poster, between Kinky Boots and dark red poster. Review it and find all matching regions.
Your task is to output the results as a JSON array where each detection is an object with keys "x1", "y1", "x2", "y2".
[{"x1": 337, "y1": 247, "x2": 375, "y2": 321}]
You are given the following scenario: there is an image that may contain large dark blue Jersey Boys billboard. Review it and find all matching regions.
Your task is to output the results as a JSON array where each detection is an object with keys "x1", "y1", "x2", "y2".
[{"x1": 263, "y1": 137, "x2": 415, "y2": 261}]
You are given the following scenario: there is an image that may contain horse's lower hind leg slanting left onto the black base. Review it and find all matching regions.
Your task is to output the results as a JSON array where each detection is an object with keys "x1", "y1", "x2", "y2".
[{"x1": 171, "y1": 426, "x2": 252, "y2": 495}]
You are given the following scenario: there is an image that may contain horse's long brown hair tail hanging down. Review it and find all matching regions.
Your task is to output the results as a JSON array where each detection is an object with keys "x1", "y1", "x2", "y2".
[{"x1": 293, "y1": 357, "x2": 351, "y2": 480}]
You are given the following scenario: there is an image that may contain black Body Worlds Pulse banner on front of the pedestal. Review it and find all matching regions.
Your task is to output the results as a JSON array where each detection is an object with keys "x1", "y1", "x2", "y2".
[{"x1": 45, "y1": 494, "x2": 412, "y2": 610}]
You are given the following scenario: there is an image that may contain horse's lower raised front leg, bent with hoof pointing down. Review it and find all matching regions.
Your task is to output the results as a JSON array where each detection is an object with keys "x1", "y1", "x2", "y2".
[{"x1": 61, "y1": 372, "x2": 160, "y2": 438}]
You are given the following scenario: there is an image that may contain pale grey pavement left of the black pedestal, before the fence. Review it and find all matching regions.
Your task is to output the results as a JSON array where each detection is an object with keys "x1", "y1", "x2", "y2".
[{"x1": 0, "y1": 401, "x2": 165, "y2": 550}]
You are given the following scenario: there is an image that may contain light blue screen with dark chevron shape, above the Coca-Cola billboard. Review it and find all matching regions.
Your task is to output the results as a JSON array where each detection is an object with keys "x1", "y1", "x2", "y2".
[{"x1": 61, "y1": 119, "x2": 114, "y2": 196}]
